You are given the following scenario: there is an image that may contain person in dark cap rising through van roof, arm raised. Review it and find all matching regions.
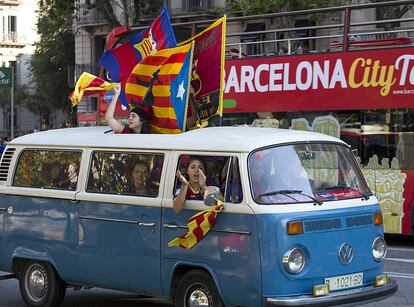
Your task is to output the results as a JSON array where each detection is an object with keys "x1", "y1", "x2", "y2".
[{"x1": 105, "y1": 83, "x2": 150, "y2": 134}]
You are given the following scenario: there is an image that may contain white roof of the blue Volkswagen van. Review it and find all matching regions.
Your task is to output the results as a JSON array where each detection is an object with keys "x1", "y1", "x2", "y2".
[{"x1": 8, "y1": 127, "x2": 343, "y2": 152}]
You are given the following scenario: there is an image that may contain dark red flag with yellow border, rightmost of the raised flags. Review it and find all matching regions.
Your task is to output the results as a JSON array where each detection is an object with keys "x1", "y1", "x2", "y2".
[{"x1": 179, "y1": 16, "x2": 226, "y2": 126}]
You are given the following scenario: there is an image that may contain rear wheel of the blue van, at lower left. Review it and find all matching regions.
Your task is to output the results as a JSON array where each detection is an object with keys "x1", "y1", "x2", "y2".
[{"x1": 19, "y1": 261, "x2": 66, "y2": 307}]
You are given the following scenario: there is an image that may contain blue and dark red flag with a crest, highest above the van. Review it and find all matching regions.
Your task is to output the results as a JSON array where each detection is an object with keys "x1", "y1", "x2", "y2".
[{"x1": 99, "y1": 4, "x2": 177, "y2": 109}]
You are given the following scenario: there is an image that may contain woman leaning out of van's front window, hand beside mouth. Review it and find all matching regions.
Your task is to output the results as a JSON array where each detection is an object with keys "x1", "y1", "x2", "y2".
[{"x1": 173, "y1": 157, "x2": 206, "y2": 213}]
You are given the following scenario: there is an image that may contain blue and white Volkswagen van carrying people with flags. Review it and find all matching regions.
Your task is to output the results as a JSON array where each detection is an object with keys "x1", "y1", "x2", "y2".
[{"x1": 0, "y1": 127, "x2": 397, "y2": 307}]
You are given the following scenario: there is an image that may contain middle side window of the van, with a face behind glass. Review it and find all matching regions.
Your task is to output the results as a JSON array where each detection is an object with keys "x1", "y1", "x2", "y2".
[{"x1": 86, "y1": 151, "x2": 164, "y2": 197}]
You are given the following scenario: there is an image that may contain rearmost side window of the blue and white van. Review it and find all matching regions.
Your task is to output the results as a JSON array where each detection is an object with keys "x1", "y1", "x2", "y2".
[{"x1": 13, "y1": 149, "x2": 82, "y2": 191}]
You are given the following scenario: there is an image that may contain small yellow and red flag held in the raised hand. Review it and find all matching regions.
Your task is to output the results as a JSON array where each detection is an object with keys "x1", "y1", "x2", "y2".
[{"x1": 69, "y1": 72, "x2": 116, "y2": 107}]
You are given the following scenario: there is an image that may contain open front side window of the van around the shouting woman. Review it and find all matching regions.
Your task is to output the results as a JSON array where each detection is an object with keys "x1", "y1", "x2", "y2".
[{"x1": 174, "y1": 155, "x2": 243, "y2": 203}]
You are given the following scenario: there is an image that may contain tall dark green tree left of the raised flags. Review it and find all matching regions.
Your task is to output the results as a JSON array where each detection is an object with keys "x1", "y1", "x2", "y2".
[{"x1": 23, "y1": 0, "x2": 75, "y2": 124}]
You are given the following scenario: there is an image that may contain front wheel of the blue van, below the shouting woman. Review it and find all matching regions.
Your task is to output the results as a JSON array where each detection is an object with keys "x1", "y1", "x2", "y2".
[{"x1": 174, "y1": 270, "x2": 224, "y2": 307}]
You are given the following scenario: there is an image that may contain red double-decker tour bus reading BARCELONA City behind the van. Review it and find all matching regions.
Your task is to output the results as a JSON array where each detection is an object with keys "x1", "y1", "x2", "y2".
[{"x1": 98, "y1": 1, "x2": 414, "y2": 234}]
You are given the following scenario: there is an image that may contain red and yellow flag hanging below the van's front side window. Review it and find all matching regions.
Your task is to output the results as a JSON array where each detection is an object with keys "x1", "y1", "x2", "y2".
[{"x1": 168, "y1": 201, "x2": 223, "y2": 248}]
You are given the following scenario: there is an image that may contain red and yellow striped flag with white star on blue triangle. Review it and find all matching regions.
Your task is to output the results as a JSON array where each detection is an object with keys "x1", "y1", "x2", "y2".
[{"x1": 125, "y1": 43, "x2": 194, "y2": 133}]
